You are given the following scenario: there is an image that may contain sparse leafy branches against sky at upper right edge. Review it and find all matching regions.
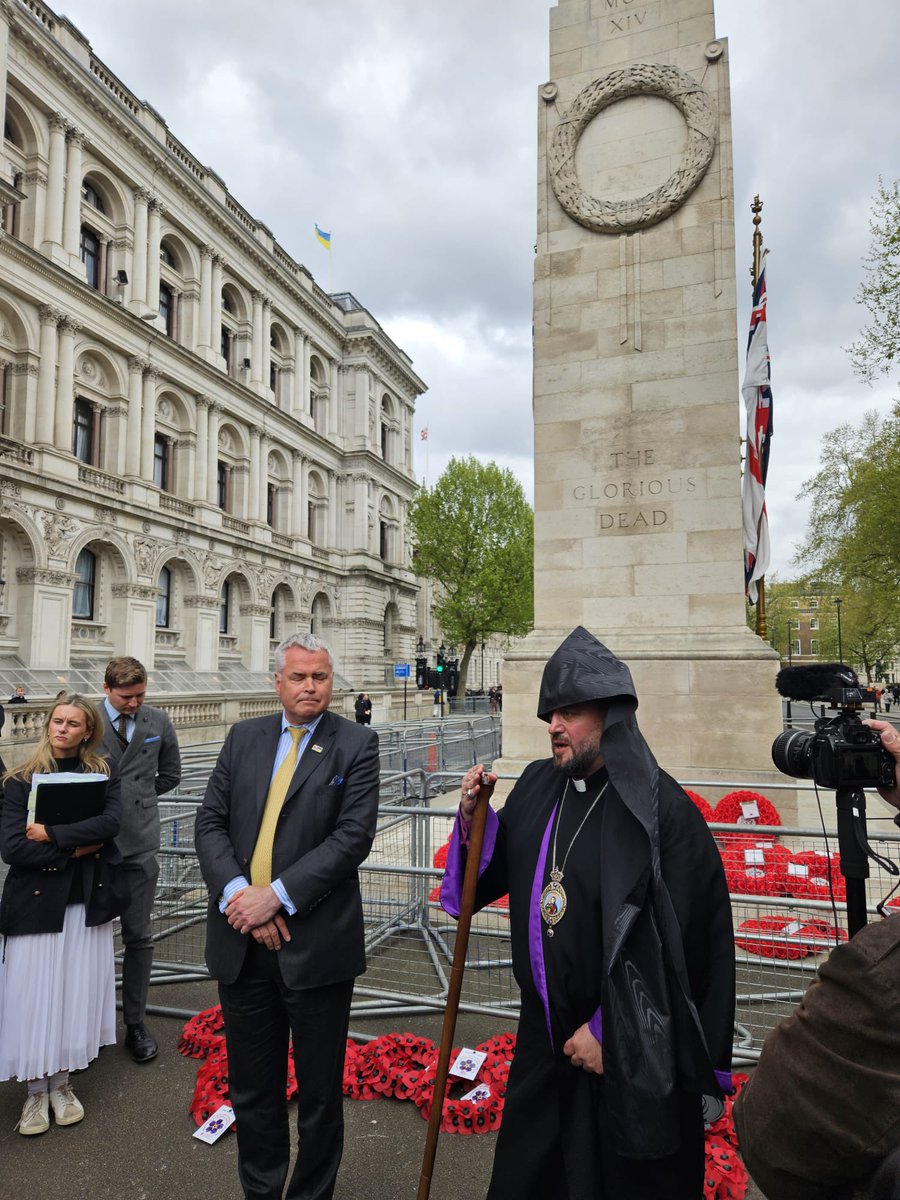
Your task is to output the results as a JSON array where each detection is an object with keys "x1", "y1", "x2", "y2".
[{"x1": 848, "y1": 179, "x2": 900, "y2": 383}]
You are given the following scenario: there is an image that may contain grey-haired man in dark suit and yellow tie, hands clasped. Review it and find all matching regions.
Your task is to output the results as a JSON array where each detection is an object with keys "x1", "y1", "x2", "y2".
[{"x1": 194, "y1": 634, "x2": 378, "y2": 1200}]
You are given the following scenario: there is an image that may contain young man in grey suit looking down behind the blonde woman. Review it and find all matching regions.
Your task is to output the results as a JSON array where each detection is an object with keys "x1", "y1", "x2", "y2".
[{"x1": 102, "y1": 658, "x2": 181, "y2": 1062}]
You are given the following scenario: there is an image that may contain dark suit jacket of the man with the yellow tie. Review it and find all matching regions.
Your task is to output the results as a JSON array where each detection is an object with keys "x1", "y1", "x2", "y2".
[{"x1": 194, "y1": 712, "x2": 379, "y2": 989}]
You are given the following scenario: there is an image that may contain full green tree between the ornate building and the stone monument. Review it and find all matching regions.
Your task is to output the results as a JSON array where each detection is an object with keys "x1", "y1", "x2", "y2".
[{"x1": 409, "y1": 457, "x2": 534, "y2": 696}]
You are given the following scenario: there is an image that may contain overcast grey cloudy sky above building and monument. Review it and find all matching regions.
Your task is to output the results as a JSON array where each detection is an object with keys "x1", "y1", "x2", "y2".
[{"x1": 55, "y1": 0, "x2": 900, "y2": 577}]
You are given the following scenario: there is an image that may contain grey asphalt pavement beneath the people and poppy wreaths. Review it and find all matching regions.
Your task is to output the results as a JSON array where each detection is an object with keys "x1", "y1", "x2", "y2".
[{"x1": 0, "y1": 982, "x2": 764, "y2": 1200}]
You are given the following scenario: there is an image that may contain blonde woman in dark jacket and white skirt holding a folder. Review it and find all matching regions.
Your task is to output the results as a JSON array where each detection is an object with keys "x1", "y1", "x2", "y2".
[{"x1": 0, "y1": 692, "x2": 121, "y2": 1135}]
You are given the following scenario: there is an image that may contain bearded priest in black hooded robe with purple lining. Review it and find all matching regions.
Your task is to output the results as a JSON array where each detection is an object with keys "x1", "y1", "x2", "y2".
[{"x1": 440, "y1": 628, "x2": 734, "y2": 1200}]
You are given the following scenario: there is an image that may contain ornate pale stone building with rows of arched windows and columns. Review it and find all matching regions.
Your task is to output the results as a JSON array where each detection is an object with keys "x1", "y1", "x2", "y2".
[{"x1": 0, "y1": 0, "x2": 425, "y2": 690}]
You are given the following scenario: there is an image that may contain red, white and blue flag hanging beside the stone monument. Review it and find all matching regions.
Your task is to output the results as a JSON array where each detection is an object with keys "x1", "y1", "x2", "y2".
[{"x1": 740, "y1": 250, "x2": 772, "y2": 604}]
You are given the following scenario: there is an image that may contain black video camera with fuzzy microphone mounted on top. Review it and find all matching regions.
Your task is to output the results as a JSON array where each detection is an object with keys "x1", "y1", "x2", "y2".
[{"x1": 772, "y1": 662, "x2": 896, "y2": 791}]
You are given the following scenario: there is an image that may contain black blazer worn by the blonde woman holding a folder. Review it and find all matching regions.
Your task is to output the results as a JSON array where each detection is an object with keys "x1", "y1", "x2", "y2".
[{"x1": 0, "y1": 764, "x2": 121, "y2": 937}]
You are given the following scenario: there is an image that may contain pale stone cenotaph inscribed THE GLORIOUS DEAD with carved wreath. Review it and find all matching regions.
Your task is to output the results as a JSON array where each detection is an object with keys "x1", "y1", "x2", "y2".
[{"x1": 499, "y1": 0, "x2": 781, "y2": 782}]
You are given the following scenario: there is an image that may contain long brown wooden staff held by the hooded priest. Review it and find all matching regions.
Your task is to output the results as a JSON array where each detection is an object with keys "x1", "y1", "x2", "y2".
[{"x1": 415, "y1": 784, "x2": 494, "y2": 1200}]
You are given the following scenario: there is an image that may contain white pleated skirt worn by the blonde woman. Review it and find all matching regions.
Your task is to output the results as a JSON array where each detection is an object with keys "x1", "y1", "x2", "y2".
[{"x1": 0, "y1": 904, "x2": 115, "y2": 1081}]
